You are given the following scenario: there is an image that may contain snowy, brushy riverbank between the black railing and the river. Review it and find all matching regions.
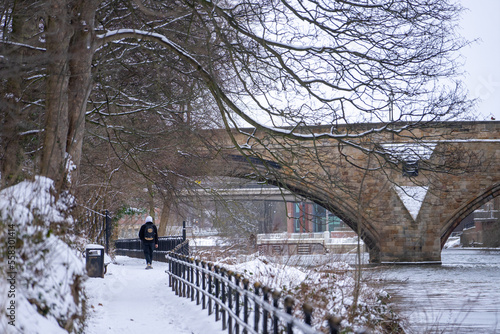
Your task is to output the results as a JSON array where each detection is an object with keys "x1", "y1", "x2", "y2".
[{"x1": 217, "y1": 255, "x2": 398, "y2": 333}]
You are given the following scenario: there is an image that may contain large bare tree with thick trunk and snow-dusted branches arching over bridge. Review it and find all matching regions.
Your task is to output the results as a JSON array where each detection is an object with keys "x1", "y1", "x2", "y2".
[{"x1": 2, "y1": 0, "x2": 468, "y2": 193}]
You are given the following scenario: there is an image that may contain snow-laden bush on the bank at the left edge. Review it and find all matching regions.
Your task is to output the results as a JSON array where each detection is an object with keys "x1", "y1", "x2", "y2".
[{"x1": 0, "y1": 177, "x2": 85, "y2": 334}]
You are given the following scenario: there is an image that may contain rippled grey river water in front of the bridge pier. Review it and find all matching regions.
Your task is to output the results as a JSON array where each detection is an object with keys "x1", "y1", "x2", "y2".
[{"x1": 365, "y1": 249, "x2": 500, "y2": 334}]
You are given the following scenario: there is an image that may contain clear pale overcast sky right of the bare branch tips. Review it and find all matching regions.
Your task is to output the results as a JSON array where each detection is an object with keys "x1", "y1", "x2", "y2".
[{"x1": 460, "y1": 0, "x2": 500, "y2": 121}]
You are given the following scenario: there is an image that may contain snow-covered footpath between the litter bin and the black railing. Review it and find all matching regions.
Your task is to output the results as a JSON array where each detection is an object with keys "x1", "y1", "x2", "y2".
[{"x1": 84, "y1": 256, "x2": 226, "y2": 334}]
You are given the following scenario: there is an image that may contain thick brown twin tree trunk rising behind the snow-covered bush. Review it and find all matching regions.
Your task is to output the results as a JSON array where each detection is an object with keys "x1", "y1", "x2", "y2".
[{"x1": 41, "y1": 0, "x2": 99, "y2": 190}]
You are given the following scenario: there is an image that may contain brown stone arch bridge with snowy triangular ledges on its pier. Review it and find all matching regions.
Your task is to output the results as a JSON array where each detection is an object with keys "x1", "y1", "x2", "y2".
[{"x1": 192, "y1": 122, "x2": 500, "y2": 263}]
